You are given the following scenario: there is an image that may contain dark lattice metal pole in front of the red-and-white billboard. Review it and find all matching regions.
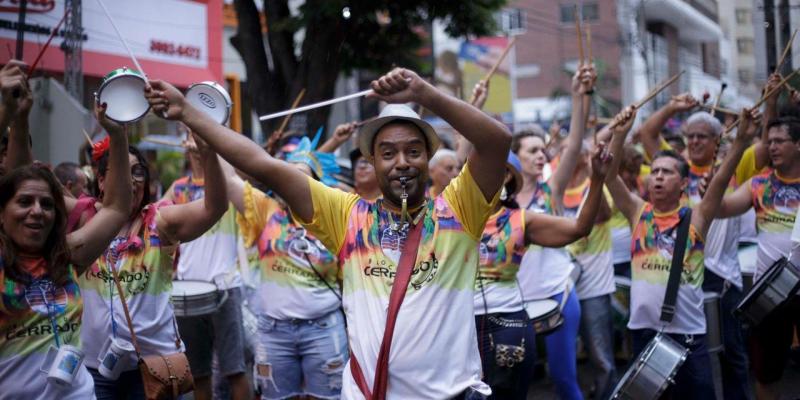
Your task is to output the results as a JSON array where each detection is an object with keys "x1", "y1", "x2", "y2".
[{"x1": 61, "y1": 0, "x2": 83, "y2": 104}]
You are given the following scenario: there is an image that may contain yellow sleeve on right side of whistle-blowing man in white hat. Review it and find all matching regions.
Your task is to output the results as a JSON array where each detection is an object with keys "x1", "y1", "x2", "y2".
[{"x1": 442, "y1": 163, "x2": 500, "y2": 240}]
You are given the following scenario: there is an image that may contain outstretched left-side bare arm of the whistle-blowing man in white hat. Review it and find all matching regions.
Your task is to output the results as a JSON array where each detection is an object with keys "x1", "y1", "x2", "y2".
[{"x1": 145, "y1": 80, "x2": 314, "y2": 221}]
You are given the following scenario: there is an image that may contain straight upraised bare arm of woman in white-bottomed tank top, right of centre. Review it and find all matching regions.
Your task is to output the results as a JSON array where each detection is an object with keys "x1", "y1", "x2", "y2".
[{"x1": 548, "y1": 66, "x2": 596, "y2": 203}]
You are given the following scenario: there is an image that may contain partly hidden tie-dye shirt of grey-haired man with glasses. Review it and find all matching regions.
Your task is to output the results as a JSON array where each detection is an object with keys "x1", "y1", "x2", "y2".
[{"x1": 686, "y1": 162, "x2": 742, "y2": 288}]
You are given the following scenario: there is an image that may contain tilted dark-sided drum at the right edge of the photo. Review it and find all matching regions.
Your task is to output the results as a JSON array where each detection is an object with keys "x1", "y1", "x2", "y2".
[{"x1": 734, "y1": 258, "x2": 800, "y2": 326}]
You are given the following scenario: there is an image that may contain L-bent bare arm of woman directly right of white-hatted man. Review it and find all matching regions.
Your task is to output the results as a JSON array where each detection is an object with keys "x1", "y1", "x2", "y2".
[{"x1": 525, "y1": 144, "x2": 611, "y2": 247}]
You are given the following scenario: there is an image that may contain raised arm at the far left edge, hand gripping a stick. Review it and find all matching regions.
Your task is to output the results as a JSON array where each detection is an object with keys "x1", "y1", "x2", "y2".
[{"x1": 0, "y1": 60, "x2": 33, "y2": 171}]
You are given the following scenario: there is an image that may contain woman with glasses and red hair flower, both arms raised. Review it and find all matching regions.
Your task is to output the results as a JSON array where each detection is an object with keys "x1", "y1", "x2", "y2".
[{"x1": 71, "y1": 114, "x2": 227, "y2": 398}]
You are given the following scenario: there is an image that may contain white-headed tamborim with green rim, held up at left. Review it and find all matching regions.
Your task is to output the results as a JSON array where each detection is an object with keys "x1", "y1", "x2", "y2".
[{"x1": 94, "y1": 67, "x2": 150, "y2": 124}]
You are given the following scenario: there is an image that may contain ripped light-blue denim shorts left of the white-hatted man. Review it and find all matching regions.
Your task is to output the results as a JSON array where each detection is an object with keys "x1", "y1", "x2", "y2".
[{"x1": 254, "y1": 310, "x2": 349, "y2": 399}]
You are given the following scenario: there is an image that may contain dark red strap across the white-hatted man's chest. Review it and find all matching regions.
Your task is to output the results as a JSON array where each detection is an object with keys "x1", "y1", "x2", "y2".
[{"x1": 350, "y1": 221, "x2": 424, "y2": 400}]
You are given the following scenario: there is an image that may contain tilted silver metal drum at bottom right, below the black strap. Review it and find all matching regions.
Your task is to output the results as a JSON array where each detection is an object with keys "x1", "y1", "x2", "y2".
[{"x1": 611, "y1": 333, "x2": 689, "y2": 400}]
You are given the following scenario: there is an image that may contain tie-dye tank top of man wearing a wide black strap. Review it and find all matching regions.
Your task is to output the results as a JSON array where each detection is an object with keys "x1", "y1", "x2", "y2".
[{"x1": 628, "y1": 203, "x2": 706, "y2": 335}]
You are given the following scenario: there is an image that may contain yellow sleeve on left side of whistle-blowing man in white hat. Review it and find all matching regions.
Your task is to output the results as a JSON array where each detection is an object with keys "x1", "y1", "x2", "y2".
[{"x1": 292, "y1": 177, "x2": 359, "y2": 254}]
